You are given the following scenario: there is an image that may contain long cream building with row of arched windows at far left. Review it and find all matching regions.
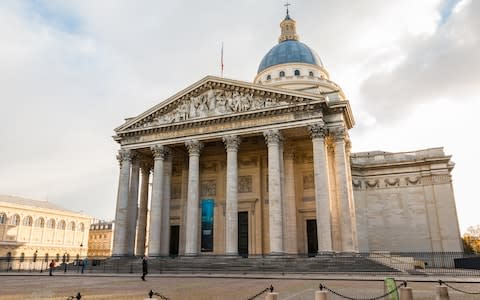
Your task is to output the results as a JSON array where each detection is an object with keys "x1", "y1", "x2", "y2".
[{"x1": 0, "y1": 195, "x2": 91, "y2": 268}]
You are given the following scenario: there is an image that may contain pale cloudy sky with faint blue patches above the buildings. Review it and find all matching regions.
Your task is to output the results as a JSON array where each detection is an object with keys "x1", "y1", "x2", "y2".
[{"x1": 0, "y1": 0, "x2": 480, "y2": 233}]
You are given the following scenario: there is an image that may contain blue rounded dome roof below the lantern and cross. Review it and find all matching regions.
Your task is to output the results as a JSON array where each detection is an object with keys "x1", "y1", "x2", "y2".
[{"x1": 257, "y1": 40, "x2": 323, "y2": 73}]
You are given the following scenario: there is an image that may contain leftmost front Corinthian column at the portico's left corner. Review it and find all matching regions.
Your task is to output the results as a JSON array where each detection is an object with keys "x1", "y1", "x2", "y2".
[{"x1": 112, "y1": 149, "x2": 132, "y2": 256}]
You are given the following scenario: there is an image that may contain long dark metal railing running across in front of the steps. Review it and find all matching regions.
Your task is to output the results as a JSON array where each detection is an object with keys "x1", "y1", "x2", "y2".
[{"x1": 0, "y1": 252, "x2": 480, "y2": 276}]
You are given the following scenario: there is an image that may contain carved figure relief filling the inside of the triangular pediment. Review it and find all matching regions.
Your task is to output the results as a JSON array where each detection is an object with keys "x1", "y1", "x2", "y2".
[{"x1": 143, "y1": 89, "x2": 288, "y2": 127}]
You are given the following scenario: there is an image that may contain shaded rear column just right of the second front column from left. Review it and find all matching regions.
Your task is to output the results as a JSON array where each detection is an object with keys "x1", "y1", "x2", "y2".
[{"x1": 160, "y1": 152, "x2": 172, "y2": 256}]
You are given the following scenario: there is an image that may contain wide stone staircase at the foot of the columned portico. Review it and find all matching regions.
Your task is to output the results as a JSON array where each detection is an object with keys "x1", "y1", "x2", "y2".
[{"x1": 89, "y1": 254, "x2": 400, "y2": 274}]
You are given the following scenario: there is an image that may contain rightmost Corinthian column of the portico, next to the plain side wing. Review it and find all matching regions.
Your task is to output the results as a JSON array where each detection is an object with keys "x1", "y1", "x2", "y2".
[{"x1": 333, "y1": 127, "x2": 357, "y2": 252}]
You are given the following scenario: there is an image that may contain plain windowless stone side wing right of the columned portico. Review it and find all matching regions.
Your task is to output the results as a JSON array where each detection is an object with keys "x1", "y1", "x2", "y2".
[{"x1": 352, "y1": 148, "x2": 462, "y2": 252}]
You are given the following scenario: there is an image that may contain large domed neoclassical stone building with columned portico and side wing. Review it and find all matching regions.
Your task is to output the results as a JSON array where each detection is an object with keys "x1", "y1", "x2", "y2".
[{"x1": 113, "y1": 11, "x2": 462, "y2": 256}]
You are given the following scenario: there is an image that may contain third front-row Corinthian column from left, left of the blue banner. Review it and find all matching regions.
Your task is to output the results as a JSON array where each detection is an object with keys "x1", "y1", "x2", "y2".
[{"x1": 185, "y1": 140, "x2": 203, "y2": 256}]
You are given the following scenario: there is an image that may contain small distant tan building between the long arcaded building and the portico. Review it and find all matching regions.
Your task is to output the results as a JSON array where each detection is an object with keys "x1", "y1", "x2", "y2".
[{"x1": 87, "y1": 221, "x2": 114, "y2": 259}]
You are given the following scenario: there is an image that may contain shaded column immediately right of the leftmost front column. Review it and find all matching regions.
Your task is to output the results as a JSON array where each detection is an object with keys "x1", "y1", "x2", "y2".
[{"x1": 127, "y1": 159, "x2": 140, "y2": 255}]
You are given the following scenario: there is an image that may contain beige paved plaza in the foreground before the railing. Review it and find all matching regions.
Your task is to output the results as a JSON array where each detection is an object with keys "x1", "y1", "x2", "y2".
[{"x1": 0, "y1": 272, "x2": 480, "y2": 300}]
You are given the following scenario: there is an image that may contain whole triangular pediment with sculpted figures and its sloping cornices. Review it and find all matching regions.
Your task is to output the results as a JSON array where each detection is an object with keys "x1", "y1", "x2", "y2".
[{"x1": 115, "y1": 76, "x2": 325, "y2": 134}]
